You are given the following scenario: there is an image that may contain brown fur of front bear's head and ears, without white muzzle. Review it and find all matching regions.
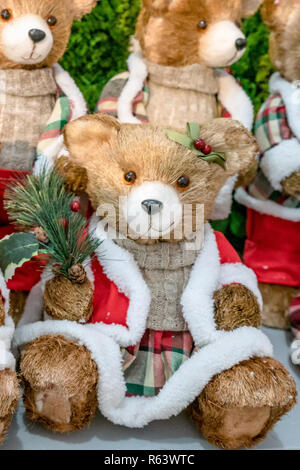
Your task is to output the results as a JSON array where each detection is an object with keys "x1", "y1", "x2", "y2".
[{"x1": 65, "y1": 114, "x2": 257, "y2": 242}]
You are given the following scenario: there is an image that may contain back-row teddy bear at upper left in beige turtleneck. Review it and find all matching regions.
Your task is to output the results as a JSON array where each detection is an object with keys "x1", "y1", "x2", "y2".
[{"x1": 0, "y1": 0, "x2": 96, "y2": 320}]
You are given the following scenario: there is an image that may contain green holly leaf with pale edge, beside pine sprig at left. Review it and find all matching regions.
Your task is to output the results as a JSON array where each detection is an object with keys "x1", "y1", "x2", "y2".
[{"x1": 0, "y1": 232, "x2": 39, "y2": 281}]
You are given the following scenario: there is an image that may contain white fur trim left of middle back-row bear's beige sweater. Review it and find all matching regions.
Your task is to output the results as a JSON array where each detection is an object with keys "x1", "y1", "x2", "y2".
[{"x1": 118, "y1": 51, "x2": 148, "y2": 124}]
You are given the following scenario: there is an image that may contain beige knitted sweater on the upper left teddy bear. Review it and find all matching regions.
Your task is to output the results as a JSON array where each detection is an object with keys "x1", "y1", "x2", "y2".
[{"x1": 0, "y1": 68, "x2": 57, "y2": 170}]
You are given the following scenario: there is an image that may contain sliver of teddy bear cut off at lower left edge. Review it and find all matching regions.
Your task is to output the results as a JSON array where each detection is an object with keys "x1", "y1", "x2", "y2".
[{"x1": 0, "y1": 271, "x2": 20, "y2": 444}]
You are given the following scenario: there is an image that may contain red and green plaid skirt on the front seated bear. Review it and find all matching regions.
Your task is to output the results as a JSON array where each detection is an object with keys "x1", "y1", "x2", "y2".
[{"x1": 122, "y1": 329, "x2": 194, "y2": 397}]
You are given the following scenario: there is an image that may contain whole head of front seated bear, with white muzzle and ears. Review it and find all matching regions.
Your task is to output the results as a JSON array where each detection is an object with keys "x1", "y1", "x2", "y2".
[{"x1": 65, "y1": 115, "x2": 257, "y2": 243}]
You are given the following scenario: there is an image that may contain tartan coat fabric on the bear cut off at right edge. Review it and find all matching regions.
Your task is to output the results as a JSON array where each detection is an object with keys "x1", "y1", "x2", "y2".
[{"x1": 249, "y1": 93, "x2": 300, "y2": 208}]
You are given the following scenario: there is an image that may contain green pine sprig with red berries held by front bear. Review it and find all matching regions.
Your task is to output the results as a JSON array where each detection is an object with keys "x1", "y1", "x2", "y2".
[{"x1": 5, "y1": 169, "x2": 100, "y2": 278}]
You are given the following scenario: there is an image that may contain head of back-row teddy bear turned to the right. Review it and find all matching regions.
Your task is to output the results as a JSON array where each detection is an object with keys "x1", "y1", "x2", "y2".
[{"x1": 137, "y1": 0, "x2": 261, "y2": 68}]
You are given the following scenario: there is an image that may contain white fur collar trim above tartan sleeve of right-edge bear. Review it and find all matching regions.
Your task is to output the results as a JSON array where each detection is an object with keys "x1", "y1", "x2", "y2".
[{"x1": 269, "y1": 72, "x2": 300, "y2": 140}]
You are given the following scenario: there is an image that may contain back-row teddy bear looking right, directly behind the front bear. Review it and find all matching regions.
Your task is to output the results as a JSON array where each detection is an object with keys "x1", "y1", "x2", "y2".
[{"x1": 92, "y1": 0, "x2": 261, "y2": 220}]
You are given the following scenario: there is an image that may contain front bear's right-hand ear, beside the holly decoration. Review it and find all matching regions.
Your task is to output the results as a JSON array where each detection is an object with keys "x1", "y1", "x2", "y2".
[{"x1": 201, "y1": 118, "x2": 258, "y2": 176}]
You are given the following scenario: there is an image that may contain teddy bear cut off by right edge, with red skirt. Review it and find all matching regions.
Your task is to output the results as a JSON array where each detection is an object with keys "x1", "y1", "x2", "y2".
[{"x1": 236, "y1": 0, "x2": 300, "y2": 334}]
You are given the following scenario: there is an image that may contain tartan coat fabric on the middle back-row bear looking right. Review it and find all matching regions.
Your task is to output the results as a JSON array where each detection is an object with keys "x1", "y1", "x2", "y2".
[{"x1": 96, "y1": 71, "x2": 231, "y2": 123}]
